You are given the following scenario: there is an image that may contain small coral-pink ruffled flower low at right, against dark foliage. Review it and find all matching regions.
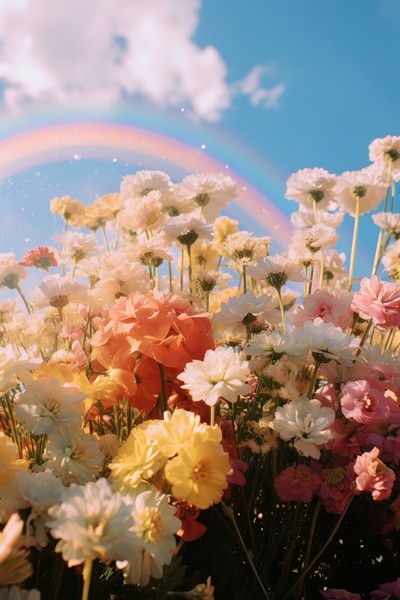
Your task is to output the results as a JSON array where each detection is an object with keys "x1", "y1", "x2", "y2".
[{"x1": 354, "y1": 447, "x2": 396, "y2": 500}]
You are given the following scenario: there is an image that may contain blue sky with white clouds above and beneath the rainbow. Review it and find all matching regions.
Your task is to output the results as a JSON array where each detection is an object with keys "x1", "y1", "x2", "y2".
[{"x1": 0, "y1": 0, "x2": 400, "y2": 276}]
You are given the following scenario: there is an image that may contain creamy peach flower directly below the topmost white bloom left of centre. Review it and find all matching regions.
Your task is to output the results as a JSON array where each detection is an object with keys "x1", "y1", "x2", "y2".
[{"x1": 117, "y1": 190, "x2": 165, "y2": 231}]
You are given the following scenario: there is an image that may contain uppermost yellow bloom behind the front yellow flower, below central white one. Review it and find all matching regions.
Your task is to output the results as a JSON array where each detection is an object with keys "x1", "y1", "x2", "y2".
[{"x1": 147, "y1": 408, "x2": 222, "y2": 458}]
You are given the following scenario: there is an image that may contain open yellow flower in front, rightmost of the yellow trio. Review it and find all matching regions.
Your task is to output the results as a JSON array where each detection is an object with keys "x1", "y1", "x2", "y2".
[{"x1": 165, "y1": 432, "x2": 231, "y2": 509}]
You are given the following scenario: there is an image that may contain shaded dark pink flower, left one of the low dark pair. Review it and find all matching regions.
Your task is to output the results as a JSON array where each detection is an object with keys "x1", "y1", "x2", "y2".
[{"x1": 274, "y1": 465, "x2": 321, "y2": 502}]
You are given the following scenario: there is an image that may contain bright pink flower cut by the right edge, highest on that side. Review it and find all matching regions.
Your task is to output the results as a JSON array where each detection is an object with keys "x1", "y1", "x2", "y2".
[{"x1": 351, "y1": 275, "x2": 400, "y2": 329}]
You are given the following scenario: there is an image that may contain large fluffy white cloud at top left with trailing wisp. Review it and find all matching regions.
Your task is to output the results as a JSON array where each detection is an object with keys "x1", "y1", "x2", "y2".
[{"x1": 0, "y1": 0, "x2": 284, "y2": 121}]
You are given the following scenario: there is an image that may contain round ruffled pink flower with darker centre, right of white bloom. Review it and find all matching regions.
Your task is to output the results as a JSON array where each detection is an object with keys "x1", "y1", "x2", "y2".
[{"x1": 340, "y1": 380, "x2": 390, "y2": 425}]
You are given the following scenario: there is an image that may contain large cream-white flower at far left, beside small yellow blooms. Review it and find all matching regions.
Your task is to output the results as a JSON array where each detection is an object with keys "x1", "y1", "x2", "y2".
[{"x1": 14, "y1": 376, "x2": 85, "y2": 435}]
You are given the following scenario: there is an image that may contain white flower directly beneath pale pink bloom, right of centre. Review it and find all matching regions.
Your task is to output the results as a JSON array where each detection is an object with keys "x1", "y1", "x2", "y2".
[{"x1": 295, "y1": 318, "x2": 360, "y2": 364}]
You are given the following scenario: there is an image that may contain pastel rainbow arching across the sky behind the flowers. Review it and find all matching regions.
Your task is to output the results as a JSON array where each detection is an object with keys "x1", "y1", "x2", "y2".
[{"x1": 0, "y1": 120, "x2": 292, "y2": 248}]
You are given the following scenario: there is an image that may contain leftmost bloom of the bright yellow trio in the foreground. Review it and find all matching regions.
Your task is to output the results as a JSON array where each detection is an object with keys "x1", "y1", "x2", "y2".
[{"x1": 108, "y1": 421, "x2": 165, "y2": 492}]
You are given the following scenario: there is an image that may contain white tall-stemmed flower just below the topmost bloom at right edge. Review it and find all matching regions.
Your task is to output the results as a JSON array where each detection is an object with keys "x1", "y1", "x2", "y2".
[{"x1": 335, "y1": 165, "x2": 386, "y2": 216}]
